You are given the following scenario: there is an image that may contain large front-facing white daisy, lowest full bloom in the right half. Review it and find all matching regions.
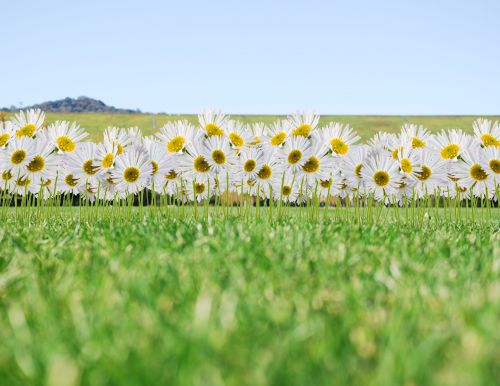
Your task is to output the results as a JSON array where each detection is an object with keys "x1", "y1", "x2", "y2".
[{"x1": 361, "y1": 155, "x2": 401, "y2": 200}]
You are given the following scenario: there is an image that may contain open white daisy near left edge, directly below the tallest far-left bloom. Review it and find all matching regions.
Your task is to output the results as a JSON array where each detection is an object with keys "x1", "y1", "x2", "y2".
[{"x1": 0, "y1": 136, "x2": 35, "y2": 177}]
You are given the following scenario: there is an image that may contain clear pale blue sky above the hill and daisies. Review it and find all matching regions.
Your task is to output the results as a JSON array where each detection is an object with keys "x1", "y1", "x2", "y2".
[{"x1": 0, "y1": 0, "x2": 500, "y2": 115}]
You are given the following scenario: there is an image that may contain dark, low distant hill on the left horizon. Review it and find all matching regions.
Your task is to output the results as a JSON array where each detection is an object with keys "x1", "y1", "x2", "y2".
[{"x1": 0, "y1": 96, "x2": 141, "y2": 114}]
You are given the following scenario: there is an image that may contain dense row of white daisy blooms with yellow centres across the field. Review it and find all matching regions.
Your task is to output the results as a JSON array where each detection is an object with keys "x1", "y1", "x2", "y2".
[{"x1": 0, "y1": 110, "x2": 500, "y2": 204}]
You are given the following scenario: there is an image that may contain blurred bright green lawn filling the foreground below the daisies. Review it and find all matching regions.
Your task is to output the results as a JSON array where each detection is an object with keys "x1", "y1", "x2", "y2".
[{"x1": 0, "y1": 212, "x2": 500, "y2": 386}]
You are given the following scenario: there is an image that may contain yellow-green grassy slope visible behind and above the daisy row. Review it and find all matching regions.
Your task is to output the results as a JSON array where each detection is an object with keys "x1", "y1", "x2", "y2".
[{"x1": 3, "y1": 113, "x2": 500, "y2": 141}]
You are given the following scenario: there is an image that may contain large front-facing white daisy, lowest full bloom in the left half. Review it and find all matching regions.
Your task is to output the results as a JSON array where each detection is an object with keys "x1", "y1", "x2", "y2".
[{"x1": 111, "y1": 147, "x2": 153, "y2": 194}]
